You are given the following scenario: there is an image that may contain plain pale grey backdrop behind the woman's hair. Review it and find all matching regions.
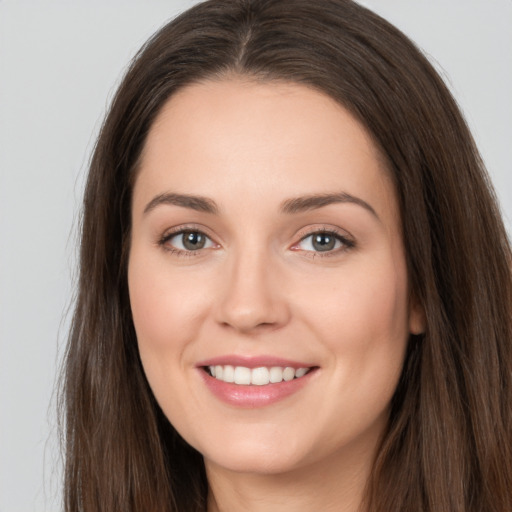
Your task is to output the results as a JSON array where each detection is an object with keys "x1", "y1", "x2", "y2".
[{"x1": 0, "y1": 0, "x2": 512, "y2": 512}]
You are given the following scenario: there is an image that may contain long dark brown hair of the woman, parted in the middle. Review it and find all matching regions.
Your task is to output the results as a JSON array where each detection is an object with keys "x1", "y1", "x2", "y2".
[{"x1": 62, "y1": 0, "x2": 512, "y2": 512}]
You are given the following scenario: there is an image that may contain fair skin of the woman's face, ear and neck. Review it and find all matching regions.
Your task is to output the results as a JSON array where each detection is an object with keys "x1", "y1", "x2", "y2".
[{"x1": 128, "y1": 77, "x2": 424, "y2": 511}]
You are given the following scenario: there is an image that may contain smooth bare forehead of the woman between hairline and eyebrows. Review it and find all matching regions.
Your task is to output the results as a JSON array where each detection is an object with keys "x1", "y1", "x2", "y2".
[{"x1": 135, "y1": 79, "x2": 394, "y2": 223}]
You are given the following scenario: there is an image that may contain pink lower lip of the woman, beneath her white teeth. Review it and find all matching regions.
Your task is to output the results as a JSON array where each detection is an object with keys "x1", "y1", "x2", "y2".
[{"x1": 199, "y1": 368, "x2": 316, "y2": 408}]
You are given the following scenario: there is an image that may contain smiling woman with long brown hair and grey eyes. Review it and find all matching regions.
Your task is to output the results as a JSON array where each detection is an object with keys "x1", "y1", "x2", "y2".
[{"x1": 64, "y1": 0, "x2": 512, "y2": 512}]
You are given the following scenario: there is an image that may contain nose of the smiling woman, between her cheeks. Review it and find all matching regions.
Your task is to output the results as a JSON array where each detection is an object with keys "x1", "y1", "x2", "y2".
[{"x1": 217, "y1": 250, "x2": 290, "y2": 333}]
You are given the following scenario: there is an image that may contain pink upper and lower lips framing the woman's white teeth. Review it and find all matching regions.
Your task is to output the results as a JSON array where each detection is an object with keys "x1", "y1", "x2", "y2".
[{"x1": 197, "y1": 356, "x2": 318, "y2": 409}]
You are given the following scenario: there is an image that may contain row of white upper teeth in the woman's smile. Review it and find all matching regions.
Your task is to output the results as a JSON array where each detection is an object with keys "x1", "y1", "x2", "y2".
[{"x1": 208, "y1": 365, "x2": 309, "y2": 386}]
